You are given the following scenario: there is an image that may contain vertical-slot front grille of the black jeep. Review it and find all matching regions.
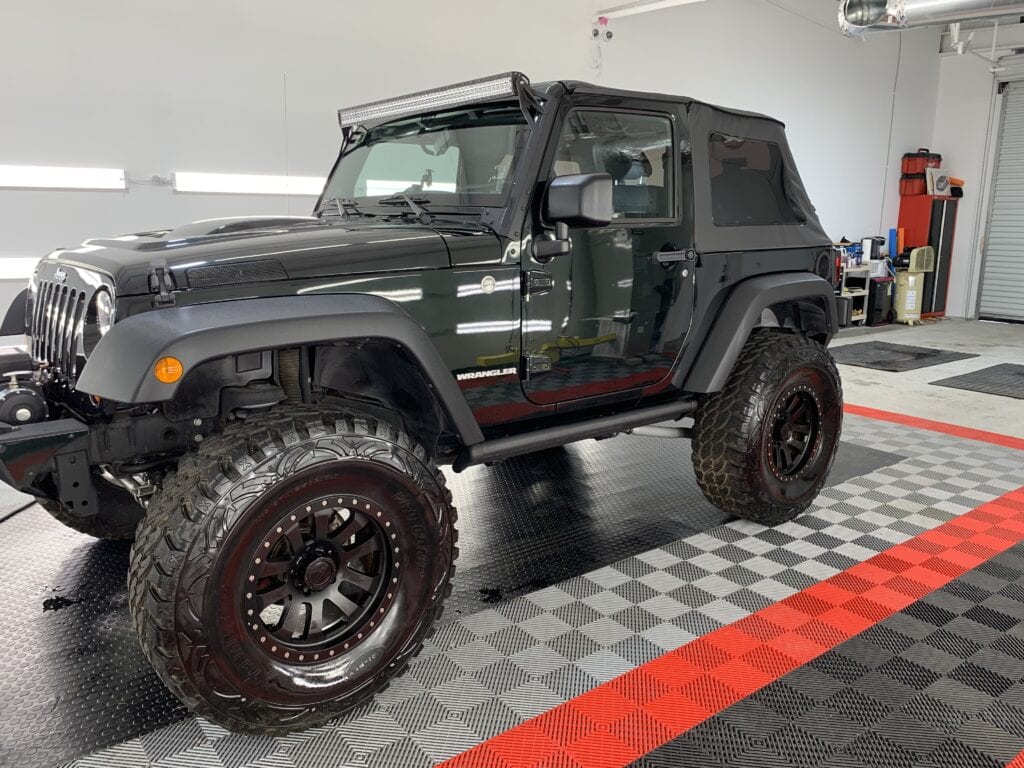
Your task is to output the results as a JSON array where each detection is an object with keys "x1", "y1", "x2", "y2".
[{"x1": 29, "y1": 267, "x2": 94, "y2": 382}]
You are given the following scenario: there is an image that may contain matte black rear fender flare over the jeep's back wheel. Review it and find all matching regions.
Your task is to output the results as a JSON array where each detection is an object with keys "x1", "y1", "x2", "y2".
[{"x1": 679, "y1": 272, "x2": 839, "y2": 392}]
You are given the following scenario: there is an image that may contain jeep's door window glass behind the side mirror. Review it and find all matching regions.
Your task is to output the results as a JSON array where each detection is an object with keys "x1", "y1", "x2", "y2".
[{"x1": 551, "y1": 110, "x2": 675, "y2": 220}]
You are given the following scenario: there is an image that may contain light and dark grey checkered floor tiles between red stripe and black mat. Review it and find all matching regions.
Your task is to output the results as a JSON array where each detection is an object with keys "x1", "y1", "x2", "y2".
[{"x1": 66, "y1": 417, "x2": 1024, "y2": 767}]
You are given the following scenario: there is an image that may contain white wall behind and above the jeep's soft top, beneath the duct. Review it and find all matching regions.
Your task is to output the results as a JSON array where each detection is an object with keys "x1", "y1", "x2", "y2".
[{"x1": 601, "y1": 0, "x2": 939, "y2": 239}]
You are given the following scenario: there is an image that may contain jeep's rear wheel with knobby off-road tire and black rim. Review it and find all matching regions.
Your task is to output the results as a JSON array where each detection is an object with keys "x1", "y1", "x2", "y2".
[{"x1": 693, "y1": 329, "x2": 843, "y2": 525}]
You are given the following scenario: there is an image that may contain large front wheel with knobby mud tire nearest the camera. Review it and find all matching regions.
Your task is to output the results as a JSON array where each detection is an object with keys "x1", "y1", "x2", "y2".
[{"x1": 129, "y1": 407, "x2": 458, "y2": 733}]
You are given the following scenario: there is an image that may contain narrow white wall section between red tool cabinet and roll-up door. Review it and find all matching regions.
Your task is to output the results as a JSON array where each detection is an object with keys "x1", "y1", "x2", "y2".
[{"x1": 932, "y1": 55, "x2": 996, "y2": 317}]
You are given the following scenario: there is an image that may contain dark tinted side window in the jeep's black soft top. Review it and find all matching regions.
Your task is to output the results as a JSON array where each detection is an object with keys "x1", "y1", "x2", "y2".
[{"x1": 708, "y1": 133, "x2": 804, "y2": 226}]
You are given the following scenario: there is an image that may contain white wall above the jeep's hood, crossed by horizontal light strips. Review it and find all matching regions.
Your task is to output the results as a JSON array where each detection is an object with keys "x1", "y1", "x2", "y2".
[{"x1": 0, "y1": 0, "x2": 597, "y2": 262}]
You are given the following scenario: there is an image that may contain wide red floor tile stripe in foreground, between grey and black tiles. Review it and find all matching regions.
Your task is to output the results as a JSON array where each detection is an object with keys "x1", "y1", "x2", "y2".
[{"x1": 443, "y1": 487, "x2": 1024, "y2": 768}]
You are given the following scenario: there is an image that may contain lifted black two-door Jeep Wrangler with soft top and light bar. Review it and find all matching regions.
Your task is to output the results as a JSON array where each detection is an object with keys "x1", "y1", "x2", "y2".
[{"x1": 0, "y1": 73, "x2": 842, "y2": 732}]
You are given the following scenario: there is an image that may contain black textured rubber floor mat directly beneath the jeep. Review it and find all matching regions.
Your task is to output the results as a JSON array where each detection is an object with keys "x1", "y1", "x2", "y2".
[{"x1": 0, "y1": 437, "x2": 904, "y2": 768}]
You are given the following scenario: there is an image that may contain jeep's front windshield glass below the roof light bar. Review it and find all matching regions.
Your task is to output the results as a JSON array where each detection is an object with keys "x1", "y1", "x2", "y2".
[{"x1": 321, "y1": 104, "x2": 528, "y2": 214}]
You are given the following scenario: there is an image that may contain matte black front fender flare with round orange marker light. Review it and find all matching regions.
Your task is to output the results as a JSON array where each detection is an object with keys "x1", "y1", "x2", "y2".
[{"x1": 76, "y1": 294, "x2": 483, "y2": 445}]
